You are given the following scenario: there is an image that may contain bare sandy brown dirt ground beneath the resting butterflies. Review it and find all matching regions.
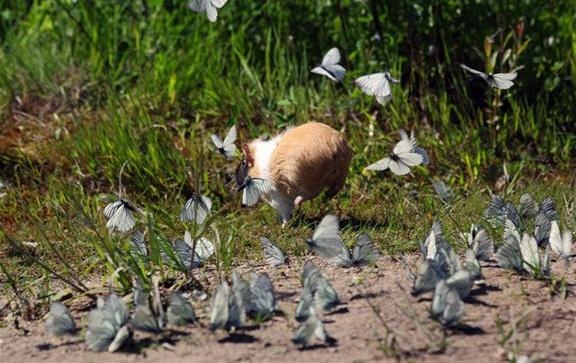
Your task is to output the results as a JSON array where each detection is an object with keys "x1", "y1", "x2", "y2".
[{"x1": 0, "y1": 256, "x2": 576, "y2": 363}]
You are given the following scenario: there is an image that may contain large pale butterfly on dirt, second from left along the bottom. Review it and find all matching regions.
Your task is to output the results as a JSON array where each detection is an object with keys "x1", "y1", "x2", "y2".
[{"x1": 86, "y1": 294, "x2": 130, "y2": 352}]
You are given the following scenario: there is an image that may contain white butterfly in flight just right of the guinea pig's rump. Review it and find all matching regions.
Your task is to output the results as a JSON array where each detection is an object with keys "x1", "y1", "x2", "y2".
[{"x1": 366, "y1": 137, "x2": 424, "y2": 175}]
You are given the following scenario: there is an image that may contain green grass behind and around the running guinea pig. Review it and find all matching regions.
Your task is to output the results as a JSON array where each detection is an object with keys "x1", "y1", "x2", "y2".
[{"x1": 0, "y1": 0, "x2": 576, "y2": 310}]
